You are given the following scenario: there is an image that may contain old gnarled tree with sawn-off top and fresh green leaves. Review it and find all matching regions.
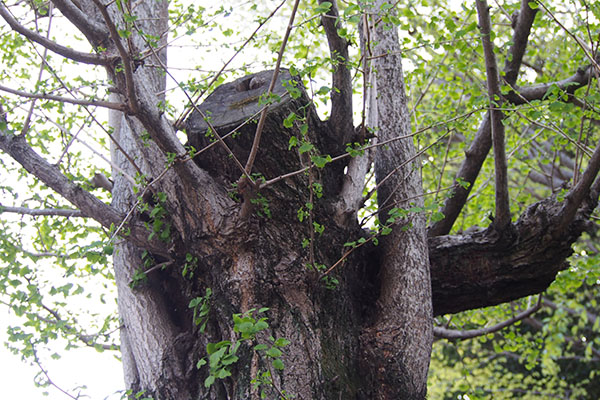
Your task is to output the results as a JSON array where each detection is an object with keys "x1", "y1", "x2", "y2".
[{"x1": 0, "y1": 0, "x2": 600, "y2": 399}]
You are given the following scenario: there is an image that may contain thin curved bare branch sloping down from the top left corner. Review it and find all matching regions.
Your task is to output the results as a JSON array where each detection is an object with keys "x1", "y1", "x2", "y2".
[{"x1": 0, "y1": 3, "x2": 114, "y2": 66}]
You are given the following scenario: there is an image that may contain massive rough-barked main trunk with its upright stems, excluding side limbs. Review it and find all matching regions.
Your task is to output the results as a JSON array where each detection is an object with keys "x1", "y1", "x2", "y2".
[{"x1": 103, "y1": 2, "x2": 431, "y2": 400}]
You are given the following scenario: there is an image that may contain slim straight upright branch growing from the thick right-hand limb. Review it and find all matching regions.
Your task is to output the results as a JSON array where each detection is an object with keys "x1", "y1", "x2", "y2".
[{"x1": 475, "y1": 0, "x2": 511, "y2": 232}]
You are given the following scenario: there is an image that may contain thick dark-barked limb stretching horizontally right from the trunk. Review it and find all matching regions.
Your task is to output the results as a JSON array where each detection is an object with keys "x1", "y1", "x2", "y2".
[{"x1": 429, "y1": 192, "x2": 597, "y2": 315}]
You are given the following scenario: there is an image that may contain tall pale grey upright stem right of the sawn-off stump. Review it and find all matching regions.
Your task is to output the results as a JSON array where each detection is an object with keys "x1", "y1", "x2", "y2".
[{"x1": 362, "y1": 1, "x2": 433, "y2": 399}]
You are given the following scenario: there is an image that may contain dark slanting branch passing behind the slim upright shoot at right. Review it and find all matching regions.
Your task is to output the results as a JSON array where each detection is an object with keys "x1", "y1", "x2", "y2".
[{"x1": 428, "y1": 0, "x2": 537, "y2": 236}]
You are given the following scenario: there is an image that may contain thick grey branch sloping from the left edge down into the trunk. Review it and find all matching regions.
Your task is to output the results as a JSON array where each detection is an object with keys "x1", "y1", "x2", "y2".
[{"x1": 0, "y1": 132, "x2": 166, "y2": 254}]
